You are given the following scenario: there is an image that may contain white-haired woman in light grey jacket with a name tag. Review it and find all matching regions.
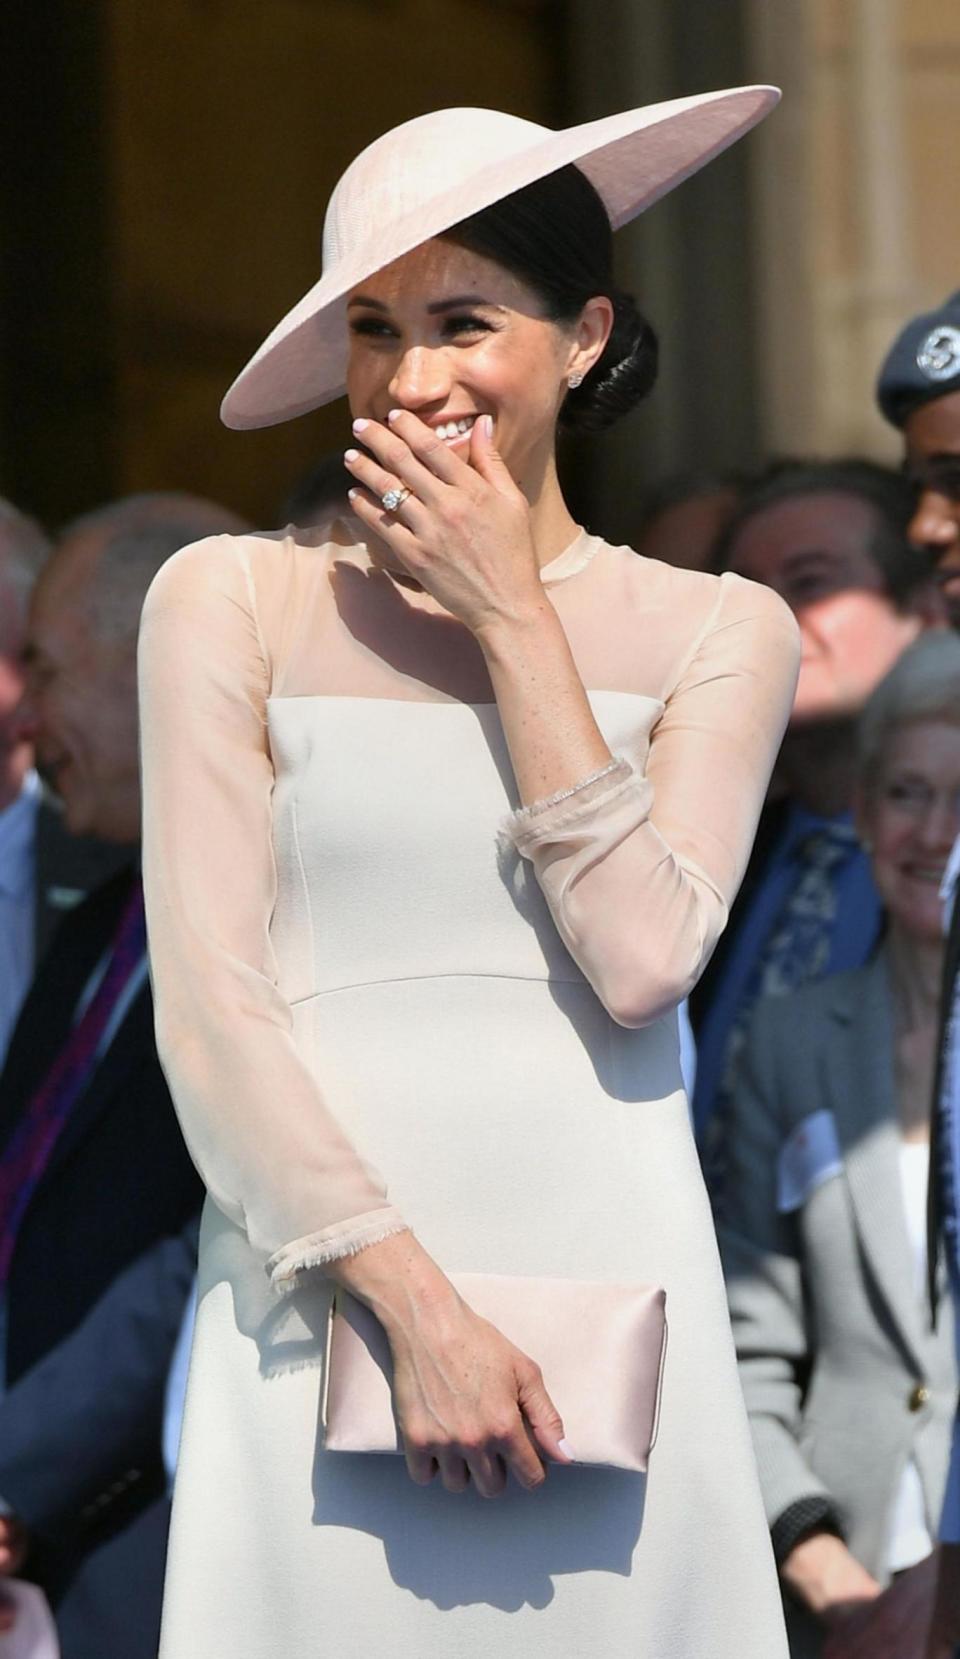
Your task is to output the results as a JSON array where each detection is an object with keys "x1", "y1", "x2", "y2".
[{"x1": 720, "y1": 632, "x2": 960, "y2": 1656}]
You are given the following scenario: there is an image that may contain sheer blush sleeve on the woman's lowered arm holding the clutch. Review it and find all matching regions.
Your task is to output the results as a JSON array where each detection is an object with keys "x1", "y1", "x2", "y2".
[{"x1": 139, "y1": 538, "x2": 405, "y2": 1284}]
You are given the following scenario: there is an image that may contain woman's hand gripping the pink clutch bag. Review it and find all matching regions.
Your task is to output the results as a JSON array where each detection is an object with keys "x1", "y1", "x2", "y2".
[{"x1": 328, "y1": 1233, "x2": 572, "y2": 1498}]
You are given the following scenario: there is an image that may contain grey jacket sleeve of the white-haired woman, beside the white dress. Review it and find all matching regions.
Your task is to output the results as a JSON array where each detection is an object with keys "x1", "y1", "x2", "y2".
[{"x1": 718, "y1": 1010, "x2": 836, "y2": 1528}]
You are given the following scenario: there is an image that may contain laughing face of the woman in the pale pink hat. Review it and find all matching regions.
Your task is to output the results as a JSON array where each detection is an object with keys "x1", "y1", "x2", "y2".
[{"x1": 347, "y1": 239, "x2": 596, "y2": 494}]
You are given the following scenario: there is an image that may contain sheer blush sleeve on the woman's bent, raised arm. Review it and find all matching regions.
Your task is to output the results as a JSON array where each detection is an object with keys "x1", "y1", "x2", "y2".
[{"x1": 511, "y1": 577, "x2": 799, "y2": 1025}]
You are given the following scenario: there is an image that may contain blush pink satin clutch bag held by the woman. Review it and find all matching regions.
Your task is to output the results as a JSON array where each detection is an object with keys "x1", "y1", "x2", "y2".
[{"x1": 323, "y1": 1272, "x2": 667, "y2": 1473}]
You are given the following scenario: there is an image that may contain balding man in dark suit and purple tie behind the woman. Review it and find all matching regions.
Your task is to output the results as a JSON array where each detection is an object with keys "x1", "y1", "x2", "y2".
[{"x1": 0, "y1": 496, "x2": 242, "y2": 1659}]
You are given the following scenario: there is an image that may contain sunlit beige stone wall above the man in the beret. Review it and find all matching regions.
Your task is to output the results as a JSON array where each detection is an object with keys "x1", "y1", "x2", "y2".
[{"x1": 748, "y1": 0, "x2": 960, "y2": 456}]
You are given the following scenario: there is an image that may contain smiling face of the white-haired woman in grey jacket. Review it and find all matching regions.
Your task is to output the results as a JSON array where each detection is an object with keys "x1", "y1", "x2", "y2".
[{"x1": 859, "y1": 720, "x2": 960, "y2": 944}]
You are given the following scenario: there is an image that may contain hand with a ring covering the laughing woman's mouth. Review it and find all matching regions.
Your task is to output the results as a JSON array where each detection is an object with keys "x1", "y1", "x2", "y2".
[{"x1": 345, "y1": 410, "x2": 544, "y2": 634}]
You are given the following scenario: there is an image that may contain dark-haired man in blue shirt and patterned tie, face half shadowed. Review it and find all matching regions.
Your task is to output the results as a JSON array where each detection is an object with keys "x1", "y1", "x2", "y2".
[{"x1": 691, "y1": 461, "x2": 945, "y2": 1148}]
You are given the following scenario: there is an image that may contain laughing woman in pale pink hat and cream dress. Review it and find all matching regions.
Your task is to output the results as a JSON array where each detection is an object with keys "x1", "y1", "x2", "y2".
[{"x1": 141, "y1": 88, "x2": 798, "y2": 1659}]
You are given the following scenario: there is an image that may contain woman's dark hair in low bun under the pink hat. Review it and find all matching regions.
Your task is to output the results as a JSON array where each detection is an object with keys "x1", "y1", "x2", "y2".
[{"x1": 444, "y1": 166, "x2": 657, "y2": 431}]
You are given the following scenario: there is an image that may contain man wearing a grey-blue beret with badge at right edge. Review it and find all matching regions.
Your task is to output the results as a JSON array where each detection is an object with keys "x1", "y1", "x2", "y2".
[{"x1": 877, "y1": 292, "x2": 960, "y2": 1659}]
